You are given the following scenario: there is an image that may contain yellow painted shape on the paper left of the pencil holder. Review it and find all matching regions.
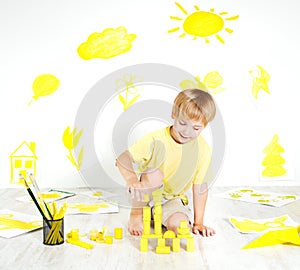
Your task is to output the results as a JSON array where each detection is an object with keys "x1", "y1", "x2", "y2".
[{"x1": 0, "y1": 214, "x2": 42, "y2": 230}]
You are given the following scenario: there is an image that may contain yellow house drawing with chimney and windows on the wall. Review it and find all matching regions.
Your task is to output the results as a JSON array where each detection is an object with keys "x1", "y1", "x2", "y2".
[{"x1": 9, "y1": 141, "x2": 38, "y2": 185}]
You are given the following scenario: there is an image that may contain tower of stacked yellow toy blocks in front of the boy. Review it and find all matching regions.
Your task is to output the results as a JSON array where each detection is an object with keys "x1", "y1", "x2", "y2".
[{"x1": 140, "y1": 190, "x2": 194, "y2": 254}]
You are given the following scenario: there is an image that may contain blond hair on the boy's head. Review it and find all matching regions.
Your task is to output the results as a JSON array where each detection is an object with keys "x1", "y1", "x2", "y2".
[{"x1": 172, "y1": 89, "x2": 216, "y2": 126}]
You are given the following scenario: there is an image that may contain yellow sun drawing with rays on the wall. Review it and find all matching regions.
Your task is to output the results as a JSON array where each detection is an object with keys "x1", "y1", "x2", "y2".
[{"x1": 168, "y1": 2, "x2": 239, "y2": 44}]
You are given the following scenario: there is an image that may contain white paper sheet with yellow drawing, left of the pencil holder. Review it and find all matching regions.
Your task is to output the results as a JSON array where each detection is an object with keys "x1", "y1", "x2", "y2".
[{"x1": 0, "y1": 209, "x2": 43, "y2": 238}]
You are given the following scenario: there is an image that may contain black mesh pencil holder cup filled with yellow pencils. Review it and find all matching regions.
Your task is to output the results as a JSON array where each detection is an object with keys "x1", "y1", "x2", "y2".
[{"x1": 43, "y1": 218, "x2": 64, "y2": 246}]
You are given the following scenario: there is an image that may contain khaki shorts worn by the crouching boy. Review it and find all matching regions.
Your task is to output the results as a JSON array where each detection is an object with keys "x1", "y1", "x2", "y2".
[{"x1": 152, "y1": 198, "x2": 193, "y2": 226}]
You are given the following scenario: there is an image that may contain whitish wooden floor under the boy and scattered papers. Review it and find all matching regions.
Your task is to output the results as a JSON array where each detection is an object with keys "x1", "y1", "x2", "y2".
[{"x1": 0, "y1": 187, "x2": 300, "y2": 270}]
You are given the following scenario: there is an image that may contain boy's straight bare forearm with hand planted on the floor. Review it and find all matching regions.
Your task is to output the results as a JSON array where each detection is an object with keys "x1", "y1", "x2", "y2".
[{"x1": 193, "y1": 184, "x2": 215, "y2": 236}]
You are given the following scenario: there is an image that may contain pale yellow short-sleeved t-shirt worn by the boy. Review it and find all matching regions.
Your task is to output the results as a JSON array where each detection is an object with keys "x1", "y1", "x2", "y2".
[{"x1": 128, "y1": 126, "x2": 211, "y2": 198}]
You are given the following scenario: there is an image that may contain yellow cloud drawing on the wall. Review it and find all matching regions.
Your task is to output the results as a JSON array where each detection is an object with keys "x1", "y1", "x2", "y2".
[{"x1": 77, "y1": 26, "x2": 136, "y2": 60}]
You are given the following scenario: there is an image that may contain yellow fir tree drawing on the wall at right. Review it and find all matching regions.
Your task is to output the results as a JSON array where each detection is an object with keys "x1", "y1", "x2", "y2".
[{"x1": 261, "y1": 134, "x2": 286, "y2": 177}]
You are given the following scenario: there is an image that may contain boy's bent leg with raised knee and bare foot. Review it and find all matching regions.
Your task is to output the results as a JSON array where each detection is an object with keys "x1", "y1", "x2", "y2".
[{"x1": 128, "y1": 169, "x2": 163, "y2": 235}]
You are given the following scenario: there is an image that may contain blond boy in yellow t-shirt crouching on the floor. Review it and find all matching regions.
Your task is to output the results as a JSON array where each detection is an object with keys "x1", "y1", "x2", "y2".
[{"x1": 116, "y1": 89, "x2": 216, "y2": 236}]
